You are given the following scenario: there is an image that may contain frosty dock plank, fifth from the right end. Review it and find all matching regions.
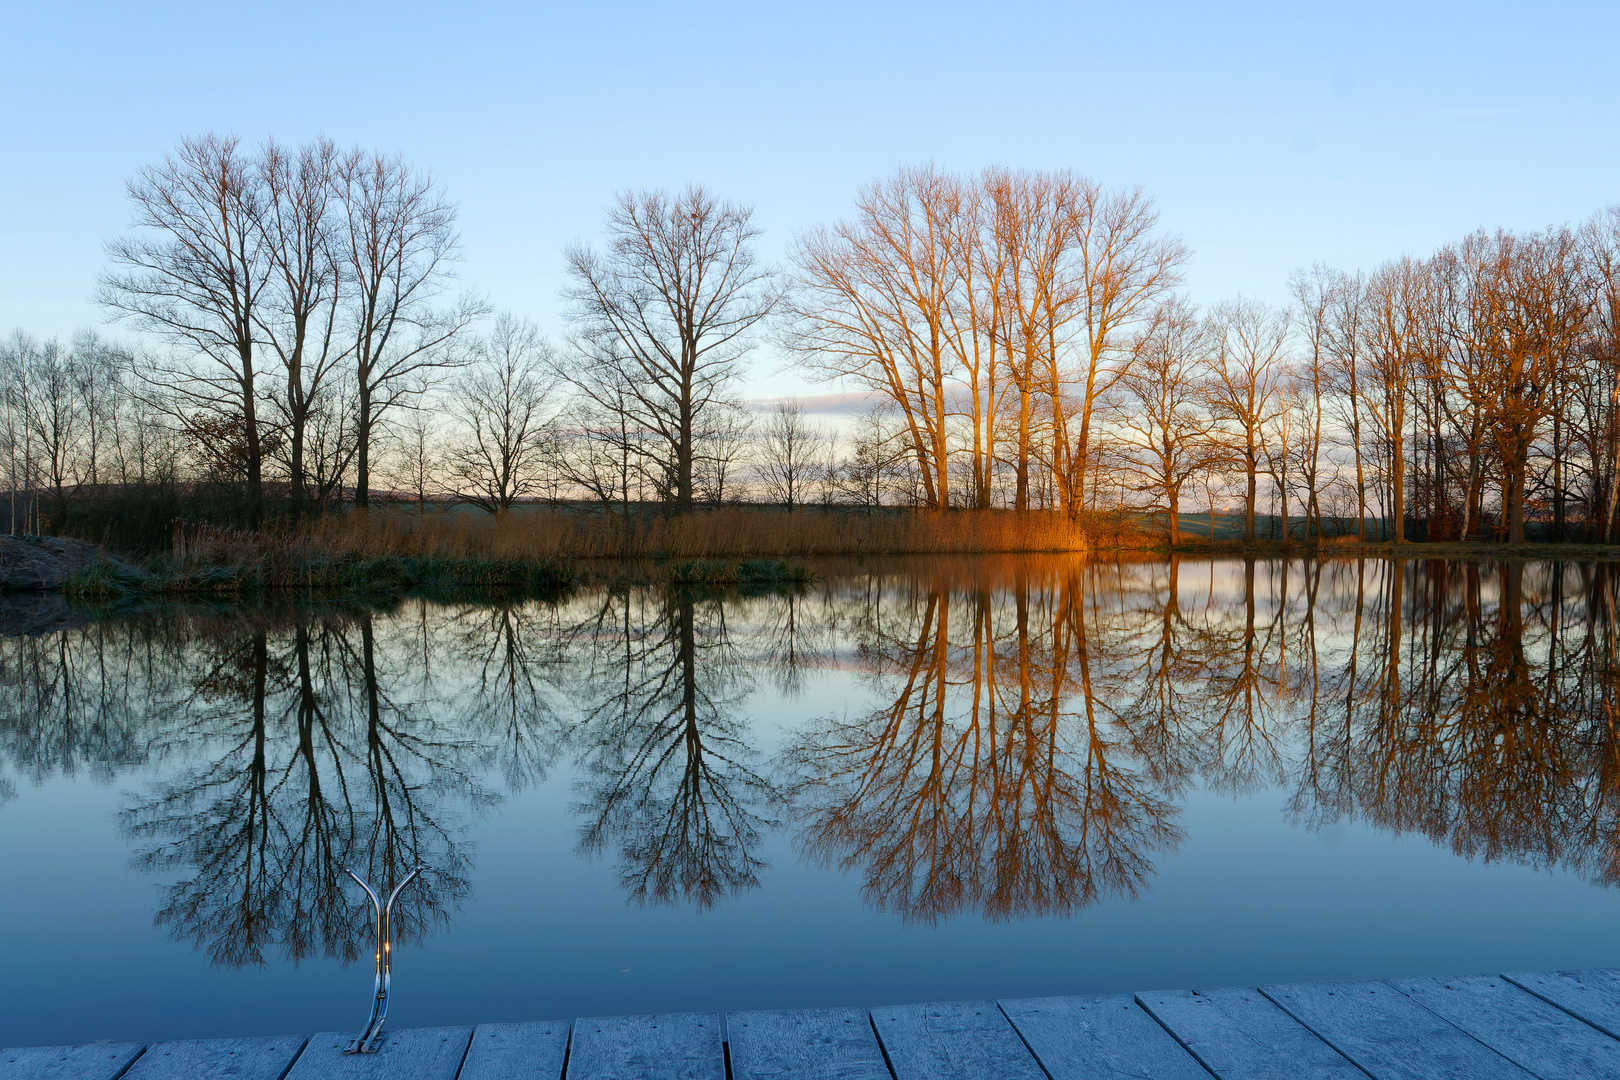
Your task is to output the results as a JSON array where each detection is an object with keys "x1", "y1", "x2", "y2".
[{"x1": 1001, "y1": 994, "x2": 1209, "y2": 1080}]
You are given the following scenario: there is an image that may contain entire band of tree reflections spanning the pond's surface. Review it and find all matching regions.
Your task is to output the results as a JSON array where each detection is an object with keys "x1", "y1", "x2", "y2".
[{"x1": 9, "y1": 559, "x2": 1620, "y2": 939}]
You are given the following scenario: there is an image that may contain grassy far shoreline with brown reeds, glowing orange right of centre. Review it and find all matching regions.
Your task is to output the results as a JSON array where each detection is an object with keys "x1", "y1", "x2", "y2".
[{"x1": 38, "y1": 507, "x2": 1620, "y2": 601}]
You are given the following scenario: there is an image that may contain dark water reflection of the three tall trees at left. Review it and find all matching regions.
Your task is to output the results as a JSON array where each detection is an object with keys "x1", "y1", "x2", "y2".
[{"x1": 125, "y1": 612, "x2": 484, "y2": 967}]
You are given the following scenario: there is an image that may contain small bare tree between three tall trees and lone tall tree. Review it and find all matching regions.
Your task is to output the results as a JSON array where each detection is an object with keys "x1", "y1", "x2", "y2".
[{"x1": 450, "y1": 313, "x2": 554, "y2": 515}]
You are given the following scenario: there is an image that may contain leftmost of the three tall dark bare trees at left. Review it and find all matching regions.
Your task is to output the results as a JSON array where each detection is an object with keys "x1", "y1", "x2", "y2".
[{"x1": 97, "y1": 134, "x2": 271, "y2": 523}]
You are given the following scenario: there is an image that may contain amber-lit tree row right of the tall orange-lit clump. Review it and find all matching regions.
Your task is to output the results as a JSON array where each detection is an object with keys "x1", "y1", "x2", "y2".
[{"x1": 1116, "y1": 216, "x2": 1620, "y2": 542}]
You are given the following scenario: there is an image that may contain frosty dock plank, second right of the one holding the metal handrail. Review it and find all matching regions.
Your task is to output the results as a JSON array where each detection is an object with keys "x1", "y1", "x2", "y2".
[{"x1": 567, "y1": 1012, "x2": 726, "y2": 1080}]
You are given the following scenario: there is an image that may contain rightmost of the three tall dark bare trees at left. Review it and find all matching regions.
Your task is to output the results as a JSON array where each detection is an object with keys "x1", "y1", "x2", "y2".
[{"x1": 334, "y1": 149, "x2": 488, "y2": 507}]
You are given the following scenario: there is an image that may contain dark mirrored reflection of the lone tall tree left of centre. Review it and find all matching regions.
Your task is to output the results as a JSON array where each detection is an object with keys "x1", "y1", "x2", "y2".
[{"x1": 572, "y1": 589, "x2": 774, "y2": 908}]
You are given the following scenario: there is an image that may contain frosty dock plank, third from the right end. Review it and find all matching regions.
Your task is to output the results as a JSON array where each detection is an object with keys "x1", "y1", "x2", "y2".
[{"x1": 1260, "y1": 983, "x2": 1531, "y2": 1080}]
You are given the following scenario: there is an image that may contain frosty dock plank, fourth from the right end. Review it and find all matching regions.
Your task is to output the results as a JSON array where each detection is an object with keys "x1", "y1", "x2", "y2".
[{"x1": 1136, "y1": 986, "x2": 1366, "y2": 1080}]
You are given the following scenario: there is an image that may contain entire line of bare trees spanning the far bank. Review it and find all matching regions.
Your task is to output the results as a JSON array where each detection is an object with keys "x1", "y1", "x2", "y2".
[{"x1": 0, "y1": 136, "x2": 1620, "y2": 541}]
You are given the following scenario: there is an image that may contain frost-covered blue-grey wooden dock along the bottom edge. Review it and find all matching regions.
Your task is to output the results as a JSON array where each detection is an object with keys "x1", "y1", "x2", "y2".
[{"x1": 0, "y1": 970, "x2": 1620, "y2": 1080}]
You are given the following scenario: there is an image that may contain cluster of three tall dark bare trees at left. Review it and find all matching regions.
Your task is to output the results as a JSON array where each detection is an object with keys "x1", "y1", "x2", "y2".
[{"x1": 97, "y1": 134, "x2": 486, "y2": 523}]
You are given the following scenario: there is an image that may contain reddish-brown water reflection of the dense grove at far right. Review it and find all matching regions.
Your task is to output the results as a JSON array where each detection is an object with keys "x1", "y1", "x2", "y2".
[{"x1": 1294, "y1": 560, "x2": 1620, "y2": 882}]
